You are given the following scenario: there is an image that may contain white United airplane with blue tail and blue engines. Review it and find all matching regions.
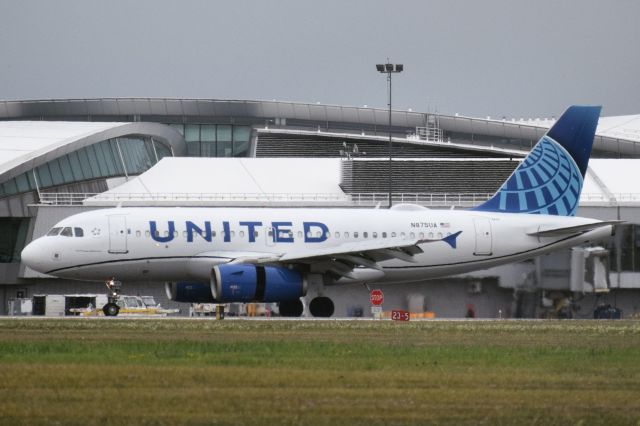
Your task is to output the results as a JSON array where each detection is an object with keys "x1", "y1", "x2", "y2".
[{"x1": 22, "y1": 106, "x2": 619, "y2": 317}]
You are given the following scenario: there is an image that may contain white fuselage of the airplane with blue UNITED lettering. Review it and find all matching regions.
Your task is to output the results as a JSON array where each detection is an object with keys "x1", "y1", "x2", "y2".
[{"x1": 23, "y1": 207, "x2": 611, "y2": 283}]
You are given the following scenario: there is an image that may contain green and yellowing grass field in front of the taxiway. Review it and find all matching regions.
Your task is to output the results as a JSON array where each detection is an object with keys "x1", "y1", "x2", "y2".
[{"x1": 0, "y1": 319, "x2": 640, "y2": 425}]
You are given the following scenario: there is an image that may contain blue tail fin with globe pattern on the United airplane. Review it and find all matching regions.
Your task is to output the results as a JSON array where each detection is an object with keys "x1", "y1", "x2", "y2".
[{"x1": 473, "y1": 106, "x2": 601, "y2": 216}]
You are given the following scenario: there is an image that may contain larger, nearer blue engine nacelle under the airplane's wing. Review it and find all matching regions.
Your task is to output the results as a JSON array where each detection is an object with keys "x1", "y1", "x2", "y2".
[{"x1": 211, "y1": 264, "x2": 307, "y2": 303}]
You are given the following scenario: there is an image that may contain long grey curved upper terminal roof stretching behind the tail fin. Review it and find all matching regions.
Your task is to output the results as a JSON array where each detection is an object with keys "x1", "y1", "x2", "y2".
[{"x1": 0, "y1": 98, "x2": 640, "y2": 156}]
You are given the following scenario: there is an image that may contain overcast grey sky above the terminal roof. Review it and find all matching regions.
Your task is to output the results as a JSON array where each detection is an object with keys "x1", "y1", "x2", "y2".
[{"x1": 0, "y1": 0, "x2": 640, "y2": 118}]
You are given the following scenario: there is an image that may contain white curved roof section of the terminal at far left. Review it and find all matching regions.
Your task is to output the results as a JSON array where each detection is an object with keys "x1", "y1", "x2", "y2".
[{"x1": 0, "y1": 121, "x2": 186, "y2": 182}]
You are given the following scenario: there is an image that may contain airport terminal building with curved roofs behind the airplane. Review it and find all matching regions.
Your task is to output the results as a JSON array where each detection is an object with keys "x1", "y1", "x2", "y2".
[{"x1": 0, "y1": 98, "x2": 640, "y2": 318}]
